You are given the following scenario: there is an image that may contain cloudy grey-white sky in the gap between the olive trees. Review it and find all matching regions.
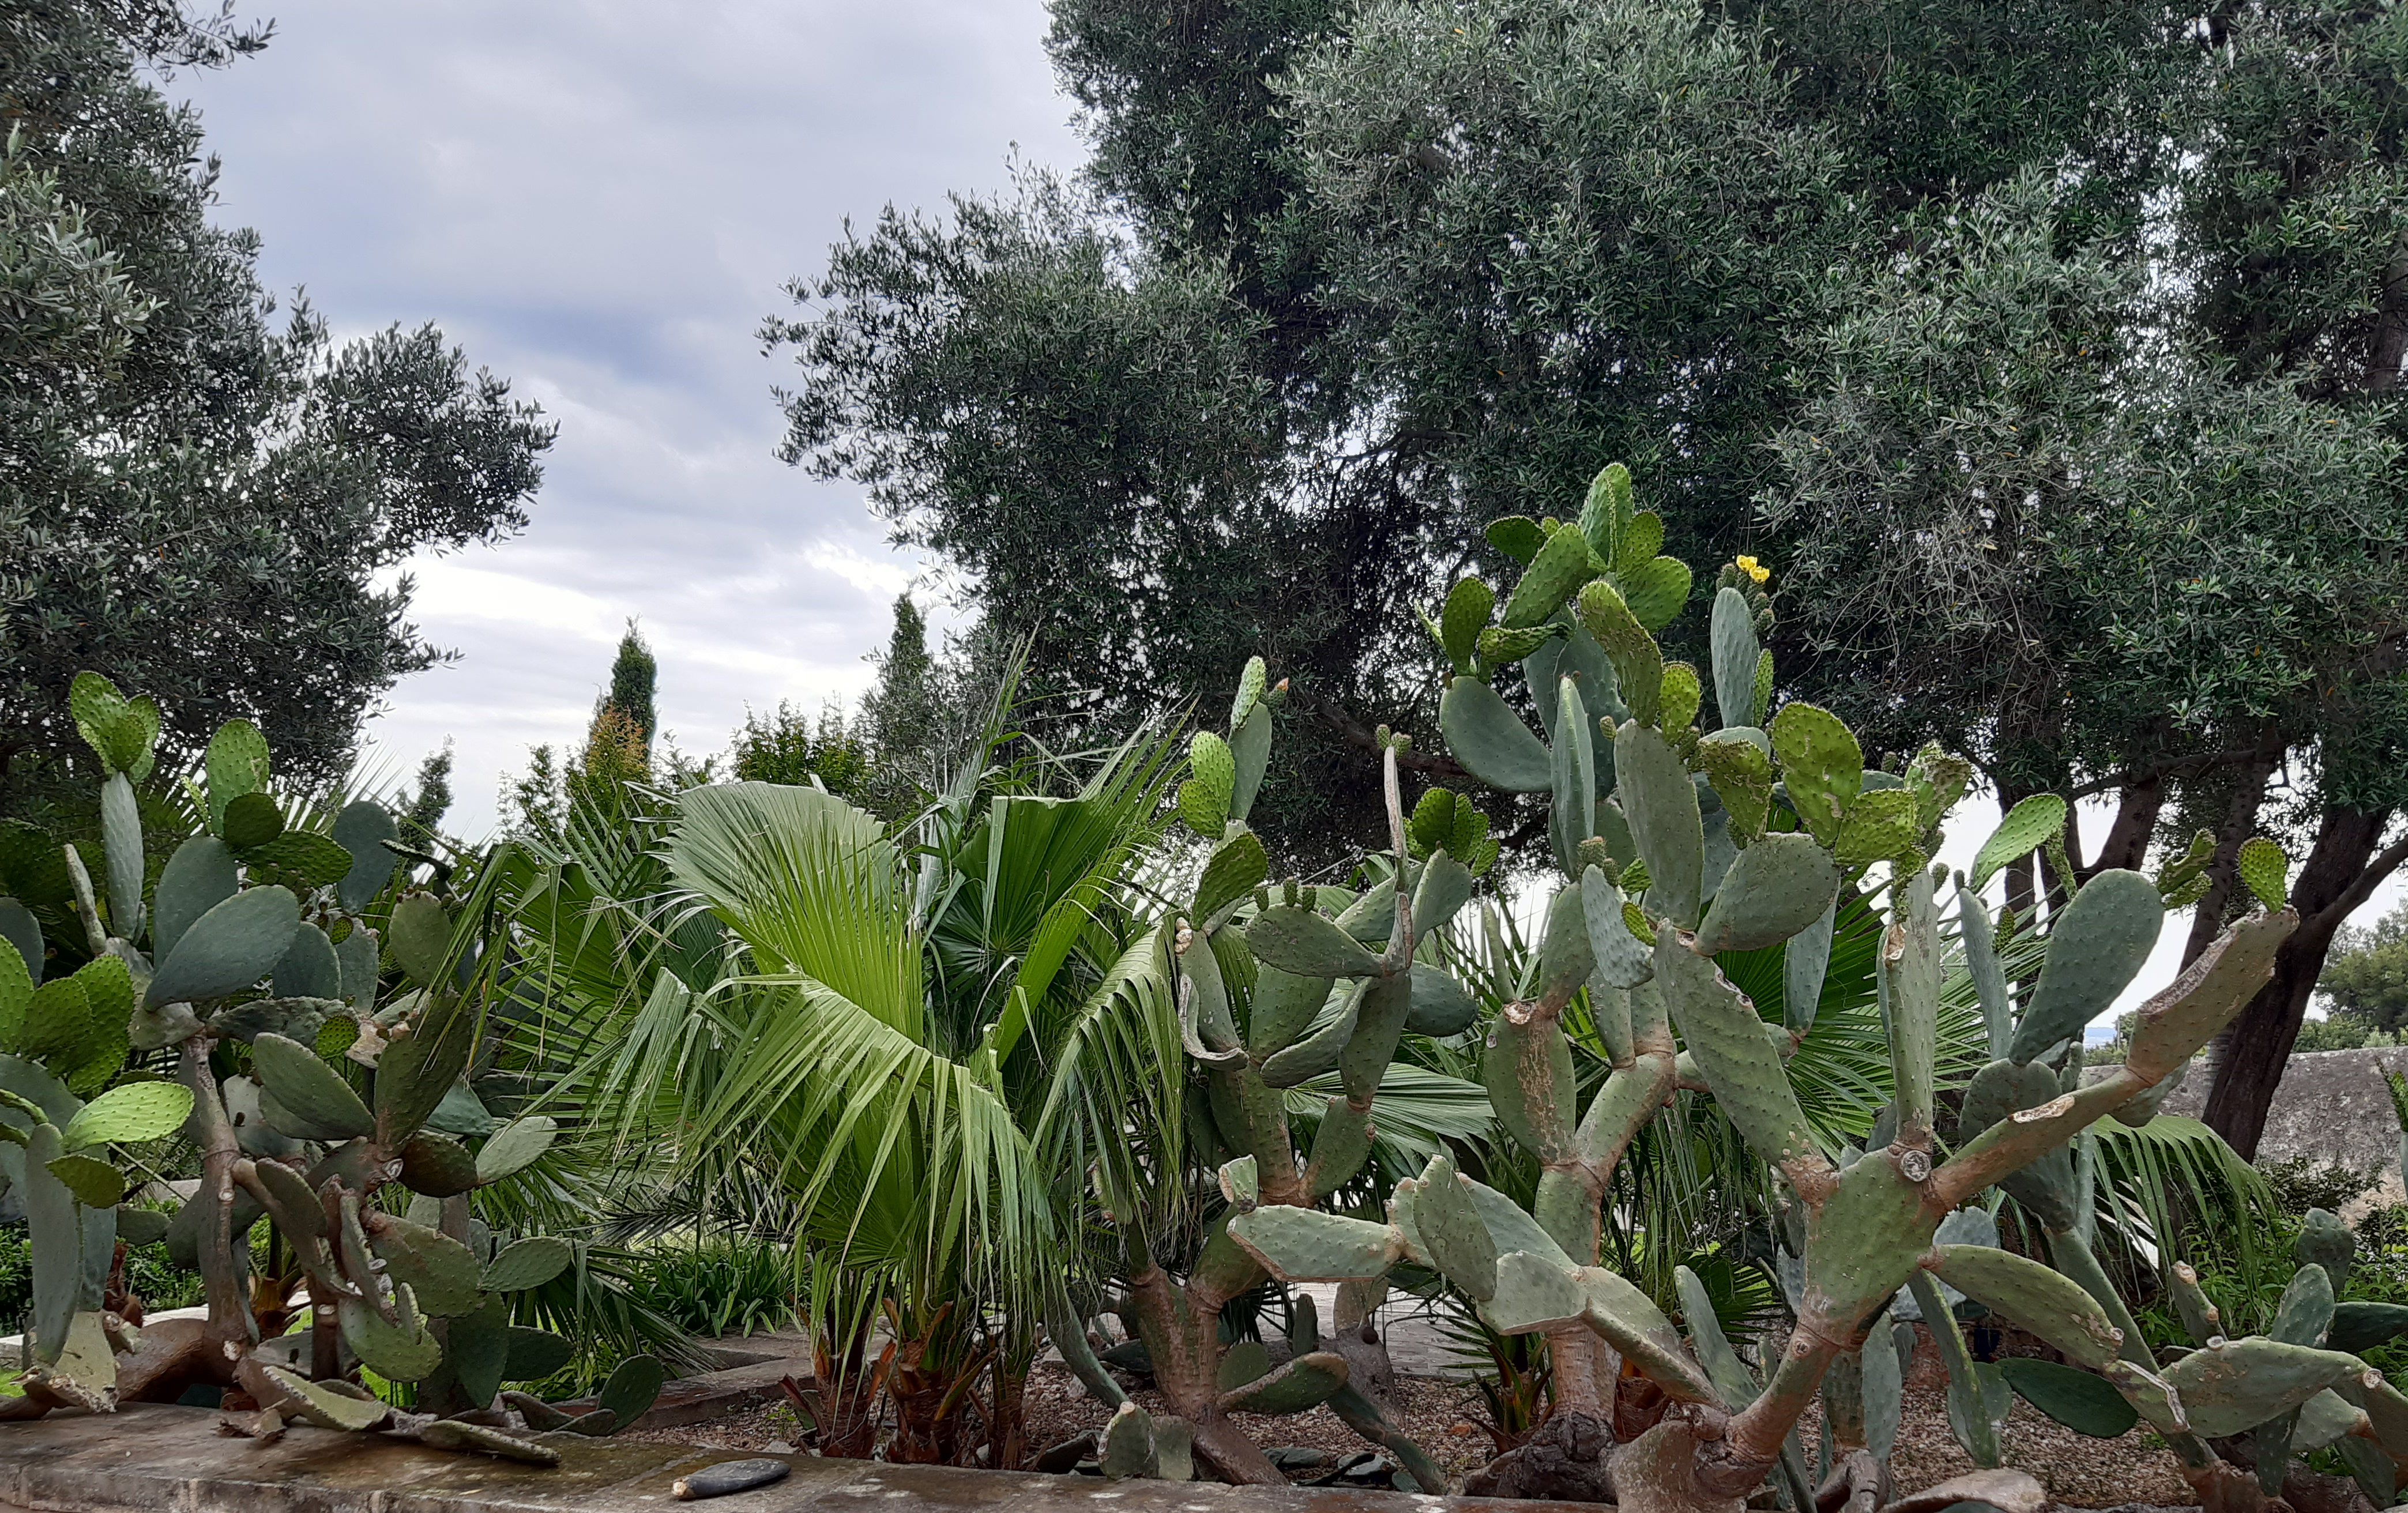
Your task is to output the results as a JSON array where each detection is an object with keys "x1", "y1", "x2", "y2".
[{"x1": 171, "y1": 0, "x2": 1081, "y2": 834}]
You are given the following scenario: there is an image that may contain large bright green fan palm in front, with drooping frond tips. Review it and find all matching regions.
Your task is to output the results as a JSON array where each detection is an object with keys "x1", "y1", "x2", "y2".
[{"x1": 494, "y1": 684, "x2": 1177, "y2": 1465}]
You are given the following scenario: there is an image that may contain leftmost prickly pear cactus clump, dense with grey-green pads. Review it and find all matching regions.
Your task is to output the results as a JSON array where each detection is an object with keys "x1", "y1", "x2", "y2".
[{"x1": 0, "y1": 675, "x2": 660, "y2": 1462}]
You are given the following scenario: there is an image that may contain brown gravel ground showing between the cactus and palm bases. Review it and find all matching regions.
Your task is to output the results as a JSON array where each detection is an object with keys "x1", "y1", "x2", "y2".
[{"x1": 624, "y1": 1364, "x2": 2196, "y2": 1508}]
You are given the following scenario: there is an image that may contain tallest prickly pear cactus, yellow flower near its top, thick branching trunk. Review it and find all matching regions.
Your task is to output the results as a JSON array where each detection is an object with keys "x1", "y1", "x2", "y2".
[{"x1": 1228, "y1": 468, "x2": 2331, "y2": 1513}]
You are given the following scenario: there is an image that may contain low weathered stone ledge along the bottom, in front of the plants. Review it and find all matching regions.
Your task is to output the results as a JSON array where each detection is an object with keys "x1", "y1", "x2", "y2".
[{"x1": 0, "y1": 1405, "x2": 1560, "y2": 1513}]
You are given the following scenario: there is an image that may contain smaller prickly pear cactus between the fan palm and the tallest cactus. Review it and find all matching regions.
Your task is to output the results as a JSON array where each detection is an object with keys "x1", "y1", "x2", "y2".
[{"x1": 1052, "y1": 658, "x2": 1493, "y2": 1491}]
